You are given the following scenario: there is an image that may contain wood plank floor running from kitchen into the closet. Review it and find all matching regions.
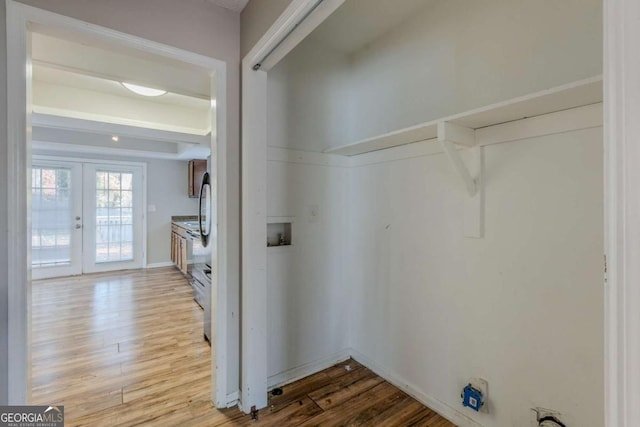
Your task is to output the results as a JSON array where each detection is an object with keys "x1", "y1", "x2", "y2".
[{"x1": 32, "y1": 268, "x2": 453, "y2": 427}]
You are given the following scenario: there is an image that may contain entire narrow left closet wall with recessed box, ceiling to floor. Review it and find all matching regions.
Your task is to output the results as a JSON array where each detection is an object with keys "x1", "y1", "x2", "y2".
[{"x1": 267, "y1": 36, "x2": 349, "y2": 385}]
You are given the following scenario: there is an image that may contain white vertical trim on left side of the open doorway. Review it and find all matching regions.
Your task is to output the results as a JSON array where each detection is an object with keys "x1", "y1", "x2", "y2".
[{"x1": 6, "y1": 0, "x2": 31, "y2": 405}]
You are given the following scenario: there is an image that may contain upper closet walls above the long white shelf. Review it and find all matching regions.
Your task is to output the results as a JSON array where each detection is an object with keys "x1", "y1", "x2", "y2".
[{"x1": 276, "y1": 0, "x2": 602, "y2": 152}]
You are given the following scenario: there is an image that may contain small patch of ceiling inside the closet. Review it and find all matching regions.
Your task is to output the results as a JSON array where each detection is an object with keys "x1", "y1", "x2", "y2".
[{"x1": 309, "y1": 0, "x2": 435, "y2": 54}]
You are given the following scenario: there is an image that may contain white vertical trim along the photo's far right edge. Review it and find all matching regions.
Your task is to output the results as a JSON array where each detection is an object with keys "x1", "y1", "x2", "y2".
[{"x1": 604, "y1": 0, "x2": 640, "y2": 427}]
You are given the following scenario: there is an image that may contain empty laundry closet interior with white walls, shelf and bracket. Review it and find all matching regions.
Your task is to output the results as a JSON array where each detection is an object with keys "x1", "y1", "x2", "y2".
[{"x1": 255, "y1": 0, "x2": 604, "y2": 427}]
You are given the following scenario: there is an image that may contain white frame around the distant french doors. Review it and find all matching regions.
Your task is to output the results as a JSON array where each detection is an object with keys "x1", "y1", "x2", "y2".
[{"x1": 31, "y1": 154, "x2": 148, "y2": 274}]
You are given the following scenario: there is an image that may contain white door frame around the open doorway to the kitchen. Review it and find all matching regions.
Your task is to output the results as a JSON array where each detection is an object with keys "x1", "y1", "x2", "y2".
[{"x1": 5, "y1": 0, "x2": 234, "y2": 408}]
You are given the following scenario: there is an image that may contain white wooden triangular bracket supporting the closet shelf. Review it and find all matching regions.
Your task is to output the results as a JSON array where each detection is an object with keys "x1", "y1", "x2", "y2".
[{"x1": 438, "y1": 122, "x2": 484, "y2": 238}]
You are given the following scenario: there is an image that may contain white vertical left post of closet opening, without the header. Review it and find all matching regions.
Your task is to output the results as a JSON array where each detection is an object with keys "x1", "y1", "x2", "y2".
[{"x1": 240, "y1": 61, "x2": 268, "y2": 413}]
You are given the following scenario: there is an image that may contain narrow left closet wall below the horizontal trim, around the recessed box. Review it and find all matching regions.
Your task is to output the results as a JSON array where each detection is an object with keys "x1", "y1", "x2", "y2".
[{"x1": 267, "y1": 155, "x2": 350, "y2": 384}]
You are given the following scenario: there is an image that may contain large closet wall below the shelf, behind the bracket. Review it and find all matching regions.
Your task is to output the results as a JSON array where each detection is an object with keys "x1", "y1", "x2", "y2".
[{"x1": 347, "y1": 128, "x2": 604, "y2": 427}]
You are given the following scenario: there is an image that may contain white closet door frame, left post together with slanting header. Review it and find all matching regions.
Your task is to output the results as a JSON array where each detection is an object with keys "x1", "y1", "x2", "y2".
[{"x1": 240, "y1": 0, "x2": 346, "y2": 413}]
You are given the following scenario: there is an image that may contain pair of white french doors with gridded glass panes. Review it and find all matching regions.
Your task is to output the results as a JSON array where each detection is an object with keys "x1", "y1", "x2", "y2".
[{"x1": 31, "y1": 158, "x2": 144, "y2": 279}]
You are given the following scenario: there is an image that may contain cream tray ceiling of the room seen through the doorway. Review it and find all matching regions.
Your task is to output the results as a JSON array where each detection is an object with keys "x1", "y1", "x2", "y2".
[{"x1": 32, "y1": 32, "x2": 215, "y2": 158}]
